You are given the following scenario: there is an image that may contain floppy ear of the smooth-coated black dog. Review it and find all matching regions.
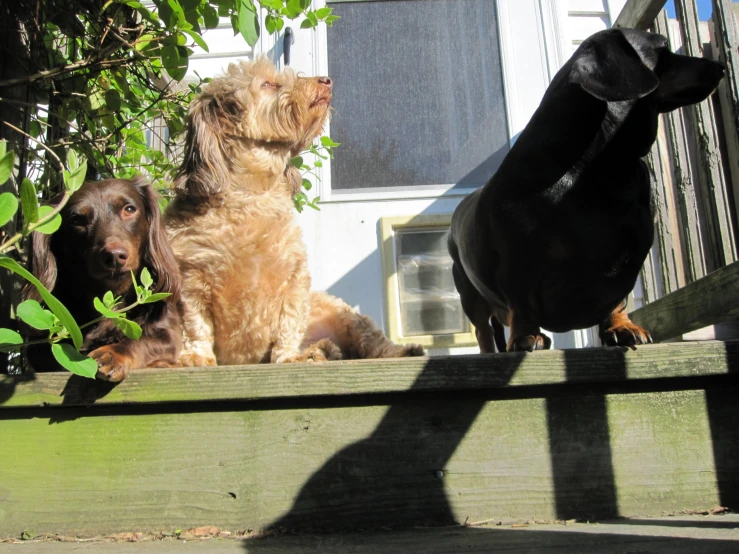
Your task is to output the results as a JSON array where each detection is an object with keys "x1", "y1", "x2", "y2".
[{"x1": 570, "y1": 29, "x2": 659, "y2": 102}]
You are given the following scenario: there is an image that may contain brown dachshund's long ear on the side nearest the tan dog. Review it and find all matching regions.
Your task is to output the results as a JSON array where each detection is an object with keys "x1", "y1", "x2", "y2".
[{"x1": 134, "y1": 179, "x2": 180, "y2": 300}]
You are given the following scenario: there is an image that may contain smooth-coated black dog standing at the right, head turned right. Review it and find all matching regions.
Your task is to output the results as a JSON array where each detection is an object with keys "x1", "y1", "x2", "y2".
[{"x1": 449, "y1": 29, "x2": 723, "y2": 352}]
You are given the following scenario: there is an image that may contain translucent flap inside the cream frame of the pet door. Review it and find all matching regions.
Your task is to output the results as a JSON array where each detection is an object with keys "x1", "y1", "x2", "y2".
[{"x1": 395, "y1": 229, "x2": 470, "y2": 337}]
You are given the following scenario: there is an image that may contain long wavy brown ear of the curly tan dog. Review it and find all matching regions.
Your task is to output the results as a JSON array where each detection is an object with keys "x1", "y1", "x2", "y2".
[{"x1": 174, "y1": 98, "x2": 229, "y2": 198}]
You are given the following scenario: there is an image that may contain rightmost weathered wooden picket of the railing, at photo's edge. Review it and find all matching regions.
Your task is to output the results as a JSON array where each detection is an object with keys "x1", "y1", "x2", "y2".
[{"x1": 711, "y1": 0, "x2": 739, "y2": 237}]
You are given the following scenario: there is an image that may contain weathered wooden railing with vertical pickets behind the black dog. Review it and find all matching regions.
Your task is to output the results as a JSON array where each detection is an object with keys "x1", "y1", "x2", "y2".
[{"x1": 614, "y1": 0, "x2": 739, "y2": 341}]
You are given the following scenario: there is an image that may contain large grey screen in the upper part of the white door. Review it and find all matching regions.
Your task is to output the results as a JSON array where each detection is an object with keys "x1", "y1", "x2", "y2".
[{"x1": 327, "y1": 0, "x2": 508, "y2": 191}]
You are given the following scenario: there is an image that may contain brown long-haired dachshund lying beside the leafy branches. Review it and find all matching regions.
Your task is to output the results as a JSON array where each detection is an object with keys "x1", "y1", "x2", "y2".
[{"x1": 24, "y1": 179, "x2": 182, "y2": 382}]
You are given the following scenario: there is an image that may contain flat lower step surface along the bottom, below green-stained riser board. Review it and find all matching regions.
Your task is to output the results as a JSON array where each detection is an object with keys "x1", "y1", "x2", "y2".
[{"x1": 0, "y1": 514, "x2": 739, "y2": 554}]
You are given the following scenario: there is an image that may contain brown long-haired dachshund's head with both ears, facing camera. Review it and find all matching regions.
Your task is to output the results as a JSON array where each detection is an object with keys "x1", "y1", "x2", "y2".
[{"x1": 27, "y1": 179, "x2": 180, "y2": 298}]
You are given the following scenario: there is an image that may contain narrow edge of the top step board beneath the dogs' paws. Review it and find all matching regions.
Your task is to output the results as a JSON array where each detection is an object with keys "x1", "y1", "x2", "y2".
[{"x1": 0, "y1": 338, "x2": 739, "y2": 412}]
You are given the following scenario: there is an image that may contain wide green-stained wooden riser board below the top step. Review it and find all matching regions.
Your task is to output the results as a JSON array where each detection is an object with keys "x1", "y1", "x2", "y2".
[{"x1": 0, "y1": 380, "x2": 739, "y2": 537}]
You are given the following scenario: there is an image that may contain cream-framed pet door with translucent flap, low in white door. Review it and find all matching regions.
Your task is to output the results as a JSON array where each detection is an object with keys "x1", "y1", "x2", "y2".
[{"x1": 381, "y1": 214, "x2": 476, "y2": 347}]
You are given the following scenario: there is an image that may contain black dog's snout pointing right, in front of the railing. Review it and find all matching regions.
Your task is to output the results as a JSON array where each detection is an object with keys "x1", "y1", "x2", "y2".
[{"x1": 655, "y1": 53, "x2": 724, "y2": 113}]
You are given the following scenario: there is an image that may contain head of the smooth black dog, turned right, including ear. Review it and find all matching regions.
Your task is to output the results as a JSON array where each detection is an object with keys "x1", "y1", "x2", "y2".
[{"x1": 567, "y1": 29, "x2": 724, "y2": 113}]
